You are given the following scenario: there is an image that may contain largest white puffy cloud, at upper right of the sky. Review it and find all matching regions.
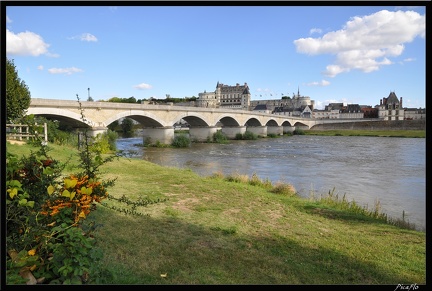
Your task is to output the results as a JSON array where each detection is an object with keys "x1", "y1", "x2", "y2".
[{"x1": 294, "y1": 10, "x2": 426, "y2": 77}]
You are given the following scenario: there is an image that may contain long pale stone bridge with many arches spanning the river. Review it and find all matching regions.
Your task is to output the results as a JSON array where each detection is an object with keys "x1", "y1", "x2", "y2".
[{"x1": 26, "y1": 98, "x2": 379, "y2": 144}]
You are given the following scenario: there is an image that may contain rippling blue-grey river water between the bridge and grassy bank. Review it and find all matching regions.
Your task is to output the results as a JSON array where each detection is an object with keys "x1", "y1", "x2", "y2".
[{"x1": 117, "y1": 135, "x2": 426, "y2": 231}]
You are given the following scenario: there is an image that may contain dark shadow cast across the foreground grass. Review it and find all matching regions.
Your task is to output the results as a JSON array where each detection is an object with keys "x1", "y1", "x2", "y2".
[{"x1": 88, "y1": 207, "x2": 425, "y2": 290}]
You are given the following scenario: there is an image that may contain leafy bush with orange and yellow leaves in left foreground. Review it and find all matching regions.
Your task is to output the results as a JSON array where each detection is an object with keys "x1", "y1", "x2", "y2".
[{"x1": 6, "y1": 95, "x2": 116, "y2": 284}]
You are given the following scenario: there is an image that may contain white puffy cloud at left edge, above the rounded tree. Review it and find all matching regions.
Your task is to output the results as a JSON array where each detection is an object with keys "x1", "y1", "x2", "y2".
[{"x1": 6, "y1": 29, "x2": 51, "y2": 57}]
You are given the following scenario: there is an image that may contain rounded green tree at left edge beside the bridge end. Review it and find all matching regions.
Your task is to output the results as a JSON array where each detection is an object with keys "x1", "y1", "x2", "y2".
[{"x1": 6, "y1": 59, "x2": 31, "y2": 123}]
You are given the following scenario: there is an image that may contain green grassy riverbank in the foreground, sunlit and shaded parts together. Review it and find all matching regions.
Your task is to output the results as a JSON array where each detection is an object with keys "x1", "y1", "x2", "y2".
[{"x1": 7, "y1": 144, "x2": 426, "y2": 288}]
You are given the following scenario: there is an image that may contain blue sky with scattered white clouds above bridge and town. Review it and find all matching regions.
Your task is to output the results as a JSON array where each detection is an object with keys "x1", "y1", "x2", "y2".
[{"x1": 3, "y1": 2, "x2": 426, "y2": 109}]
